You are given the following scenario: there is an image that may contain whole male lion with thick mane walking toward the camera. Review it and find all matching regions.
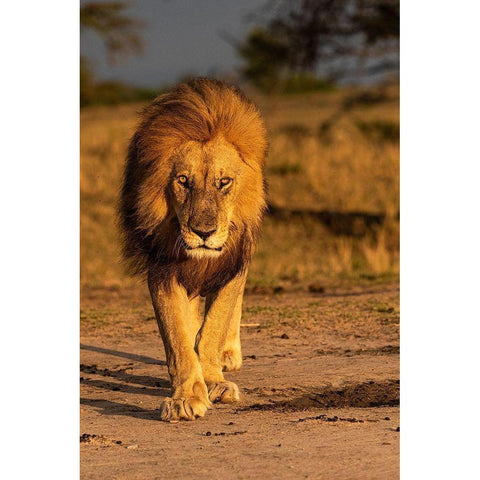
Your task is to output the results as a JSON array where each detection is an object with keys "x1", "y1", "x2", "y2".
[{"x1": 119, "y1": 78, "x2": 267, "y2": 421}]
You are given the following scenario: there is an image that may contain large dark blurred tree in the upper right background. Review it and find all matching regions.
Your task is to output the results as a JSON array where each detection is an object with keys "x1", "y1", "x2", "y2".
[{"x1": 237, "y1": 0, "x2": 399, "y2": 90}]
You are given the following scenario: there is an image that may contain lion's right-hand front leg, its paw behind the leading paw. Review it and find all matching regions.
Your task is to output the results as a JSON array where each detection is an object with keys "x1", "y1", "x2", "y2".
[{"x1": 196, "y1": 274, "x2": 246, "y2": 403}]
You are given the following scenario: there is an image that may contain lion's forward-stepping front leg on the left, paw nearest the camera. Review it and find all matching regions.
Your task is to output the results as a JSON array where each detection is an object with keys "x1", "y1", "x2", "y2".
[{"x1": 148, "y1": 276, "x2": 211, "y2": 421}]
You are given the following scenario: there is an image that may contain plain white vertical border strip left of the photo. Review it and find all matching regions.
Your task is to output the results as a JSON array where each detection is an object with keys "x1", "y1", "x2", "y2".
[{"x1": 0, "y1": 0, "x2": 79, "y2": 480}]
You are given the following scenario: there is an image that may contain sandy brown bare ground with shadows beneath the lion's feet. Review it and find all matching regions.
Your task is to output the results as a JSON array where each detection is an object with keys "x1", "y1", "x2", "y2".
[{"x1": 80, "y1": 284, "x2": 400, "y2": 480}]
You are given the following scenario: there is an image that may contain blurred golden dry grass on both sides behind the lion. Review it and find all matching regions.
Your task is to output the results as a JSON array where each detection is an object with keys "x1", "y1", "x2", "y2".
[{"x1": 80, "y1": 87, "x2": 399, "y2": 288}]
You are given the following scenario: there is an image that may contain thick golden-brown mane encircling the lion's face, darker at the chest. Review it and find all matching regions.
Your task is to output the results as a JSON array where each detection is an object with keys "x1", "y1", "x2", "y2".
[{"x1": 119, "y1": 78, "x2": 267, "y2": 295}]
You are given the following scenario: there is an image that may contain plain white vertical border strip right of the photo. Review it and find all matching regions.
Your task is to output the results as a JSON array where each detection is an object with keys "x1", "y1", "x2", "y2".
[{"x1": 400, "y1": 0, "x2": 480, "y2": 480}]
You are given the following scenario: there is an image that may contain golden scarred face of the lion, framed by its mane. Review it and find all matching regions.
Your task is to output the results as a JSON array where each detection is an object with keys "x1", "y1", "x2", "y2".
[{"x1": 170, "y1": 137, "x2": 244, "y2": 258}]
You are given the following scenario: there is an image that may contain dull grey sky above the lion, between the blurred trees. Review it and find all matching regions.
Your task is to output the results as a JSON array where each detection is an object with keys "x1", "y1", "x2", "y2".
[{"x1": 81, "y1": 0, "x2": 268, "y2": 87}]
